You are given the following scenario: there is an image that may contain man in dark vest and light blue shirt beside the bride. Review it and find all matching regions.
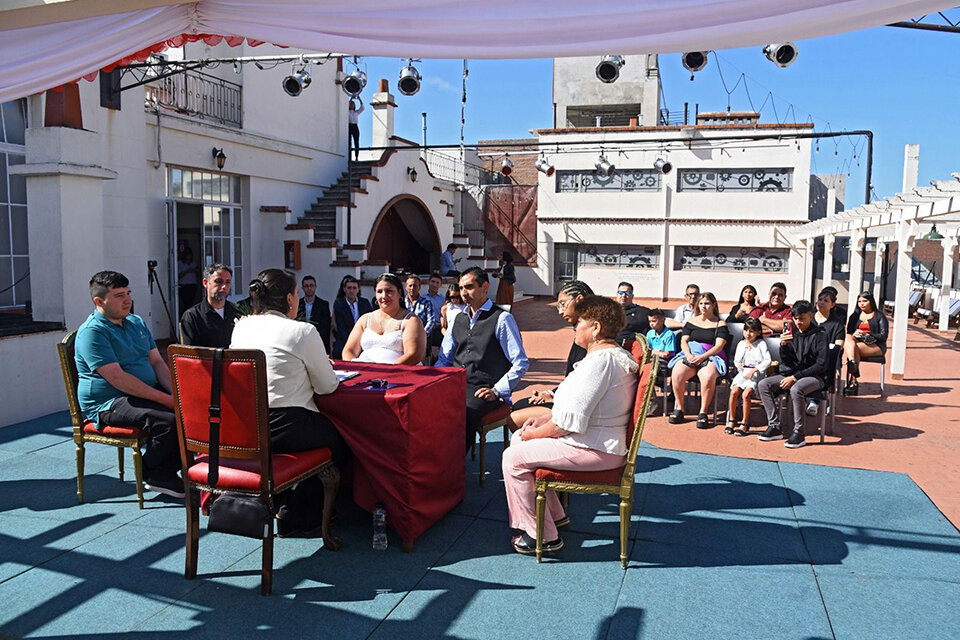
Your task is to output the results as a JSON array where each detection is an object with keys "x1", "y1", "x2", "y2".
[{"x1": 436, "y1": 267, "x2": 529, "y2": 451}]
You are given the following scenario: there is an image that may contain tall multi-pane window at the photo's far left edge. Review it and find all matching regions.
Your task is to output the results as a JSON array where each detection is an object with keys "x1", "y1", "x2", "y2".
[{"x1": 0, "y1": 99, "x2": 30, "y2": 308}]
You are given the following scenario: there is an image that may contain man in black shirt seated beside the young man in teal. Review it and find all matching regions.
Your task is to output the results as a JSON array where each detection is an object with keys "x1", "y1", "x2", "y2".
[{"x1": 180, "y1": 262, "x2": 240, "y2": 349}]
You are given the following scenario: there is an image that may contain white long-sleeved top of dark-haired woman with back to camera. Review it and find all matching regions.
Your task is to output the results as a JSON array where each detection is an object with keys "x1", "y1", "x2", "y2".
[{"x1": 230, "y1": 311, "x2": 339, "y2": 413}]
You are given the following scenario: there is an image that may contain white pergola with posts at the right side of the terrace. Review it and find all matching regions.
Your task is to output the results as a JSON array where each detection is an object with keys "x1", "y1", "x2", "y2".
[{"x1": 791, "y1": 173, "x2": 960, "y2": 380}]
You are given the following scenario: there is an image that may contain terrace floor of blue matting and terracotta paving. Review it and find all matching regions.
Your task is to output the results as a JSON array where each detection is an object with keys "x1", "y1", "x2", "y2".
[{"x1": 0, "y1": 301, "x2": 960, "y2": 640}]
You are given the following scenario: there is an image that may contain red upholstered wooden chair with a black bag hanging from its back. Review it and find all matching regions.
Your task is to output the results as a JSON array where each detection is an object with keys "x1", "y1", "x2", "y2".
[{"x1": 167, "y1": 345, "x2": 340, "y2": 595}]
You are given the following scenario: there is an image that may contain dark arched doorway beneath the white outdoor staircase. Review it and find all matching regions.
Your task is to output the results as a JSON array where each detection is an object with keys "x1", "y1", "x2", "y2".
[{"x1": 367, "y1": 194, "x2": 441, "y2": 273}]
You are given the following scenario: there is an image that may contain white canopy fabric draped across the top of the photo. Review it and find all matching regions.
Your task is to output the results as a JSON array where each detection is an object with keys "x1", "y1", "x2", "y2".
[{"x1": 0, "y1": 0, "x2": 956, "y2": 102}]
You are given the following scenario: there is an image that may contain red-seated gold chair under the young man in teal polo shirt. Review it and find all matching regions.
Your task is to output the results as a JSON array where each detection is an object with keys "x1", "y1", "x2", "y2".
[{"x1": 57, "y1": 331, "x2": 146, "y2": 509}]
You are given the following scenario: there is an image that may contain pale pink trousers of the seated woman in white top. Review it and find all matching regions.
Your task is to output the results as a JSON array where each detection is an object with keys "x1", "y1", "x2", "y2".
[{"x1": 503, "y1": 431, "x2": 623, "y2": 542}]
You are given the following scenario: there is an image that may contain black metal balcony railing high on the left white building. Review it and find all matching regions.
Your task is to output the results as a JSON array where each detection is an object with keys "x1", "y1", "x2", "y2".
[{"x1": 144, "y1": 71, "x2": 243, "y2": 128}]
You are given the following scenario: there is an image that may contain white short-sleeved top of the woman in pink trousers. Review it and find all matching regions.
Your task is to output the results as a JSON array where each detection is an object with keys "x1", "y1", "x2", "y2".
[{"x1": 553, "y1": 347, "x2": 639, "y2": 455}]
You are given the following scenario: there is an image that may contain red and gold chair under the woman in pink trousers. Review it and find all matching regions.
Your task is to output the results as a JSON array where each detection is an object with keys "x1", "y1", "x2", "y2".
[{"x1": 536, "y1": 335, "x2": 660, "y2": 569}]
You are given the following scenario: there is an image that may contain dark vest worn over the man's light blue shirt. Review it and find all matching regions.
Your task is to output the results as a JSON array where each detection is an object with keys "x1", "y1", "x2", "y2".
[{"x1": 453, "y1": 306, "x2": 513, "y2": 387}]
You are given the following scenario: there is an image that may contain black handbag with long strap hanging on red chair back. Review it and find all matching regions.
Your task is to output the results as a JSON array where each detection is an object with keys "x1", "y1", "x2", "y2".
[{"x1": 207, "y1": 349, "x2": 273, "y2": 539}]
